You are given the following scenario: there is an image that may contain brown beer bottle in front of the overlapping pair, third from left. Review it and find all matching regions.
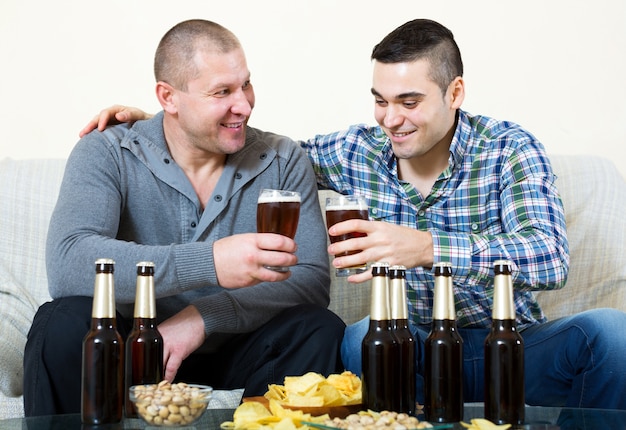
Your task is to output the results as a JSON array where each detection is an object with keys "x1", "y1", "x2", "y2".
[{"x1": 361, "y1": 263, "x2": 399, "y2": 411}]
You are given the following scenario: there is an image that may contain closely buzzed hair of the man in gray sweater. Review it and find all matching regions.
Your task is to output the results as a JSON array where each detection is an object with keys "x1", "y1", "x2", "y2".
[{"x1": 154, "y1": 19, "x2": 241, "y2": 91}]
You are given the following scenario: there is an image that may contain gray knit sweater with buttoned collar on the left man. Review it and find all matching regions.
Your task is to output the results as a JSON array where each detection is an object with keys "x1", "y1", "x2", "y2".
[{"x1": 46, "y1": 113, "x2": 330, "y2": 335}]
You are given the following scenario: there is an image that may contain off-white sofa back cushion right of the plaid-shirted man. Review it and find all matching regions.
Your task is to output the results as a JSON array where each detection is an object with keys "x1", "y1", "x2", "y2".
[{"x1": 536, "y1": 155, "x2": 626, "y2": 319}]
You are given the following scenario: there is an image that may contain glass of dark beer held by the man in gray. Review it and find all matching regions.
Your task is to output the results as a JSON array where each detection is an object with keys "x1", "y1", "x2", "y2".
[{"x1": 256, "y1": 189, "x2": 300, "y2": 272}]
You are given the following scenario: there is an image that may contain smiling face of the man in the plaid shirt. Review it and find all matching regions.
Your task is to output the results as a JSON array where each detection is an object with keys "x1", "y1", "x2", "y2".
[{"x1": 372, "y1": 59, "x2": 463, "y2": 160}]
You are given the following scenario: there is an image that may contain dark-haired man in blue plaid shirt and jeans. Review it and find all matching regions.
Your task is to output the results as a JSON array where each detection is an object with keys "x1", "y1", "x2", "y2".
[{"x1": 81, "y1": 19, "x2": 626, "y2": 409}]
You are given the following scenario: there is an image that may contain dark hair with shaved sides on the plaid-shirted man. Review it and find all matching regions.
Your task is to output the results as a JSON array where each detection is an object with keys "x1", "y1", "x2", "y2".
[{"x1": 372, "y1": 19, "x2": 463, "y2": 94}]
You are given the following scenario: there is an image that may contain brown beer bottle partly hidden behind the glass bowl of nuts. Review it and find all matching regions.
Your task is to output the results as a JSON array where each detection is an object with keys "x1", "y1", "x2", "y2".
[{"x1": 124, "y1": 261, "x2": 163, "y2": 417}]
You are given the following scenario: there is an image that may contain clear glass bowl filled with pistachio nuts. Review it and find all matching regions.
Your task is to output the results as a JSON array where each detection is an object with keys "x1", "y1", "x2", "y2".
[{"x1": 128, "y1": 381, "x2": 213, "y2": 427}]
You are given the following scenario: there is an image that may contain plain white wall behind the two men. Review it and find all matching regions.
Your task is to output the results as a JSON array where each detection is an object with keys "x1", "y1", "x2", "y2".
[{"x1": 0, "y1": 0, "x2": 626, "y2": 176}]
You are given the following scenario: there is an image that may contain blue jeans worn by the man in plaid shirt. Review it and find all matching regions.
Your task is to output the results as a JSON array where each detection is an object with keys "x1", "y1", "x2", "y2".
[{"x1": 341, "y1": 309, "x2": 626, "y2": 409}]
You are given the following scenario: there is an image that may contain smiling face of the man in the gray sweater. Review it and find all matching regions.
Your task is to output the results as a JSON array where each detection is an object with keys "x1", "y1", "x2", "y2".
[{"x1": 162, "y1": 48, "x2": 254, "y2": 158}]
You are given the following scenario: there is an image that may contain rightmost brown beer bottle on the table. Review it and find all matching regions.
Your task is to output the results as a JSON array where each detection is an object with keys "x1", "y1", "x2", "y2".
[{"x1": 485, "y1": 260, "x2": 524, "y2": 425}]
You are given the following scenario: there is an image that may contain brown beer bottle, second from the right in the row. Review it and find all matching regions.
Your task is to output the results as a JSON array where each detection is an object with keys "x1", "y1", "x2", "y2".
[{"x1": 424, "y1": 262, "x2": 463, "y2": 423}]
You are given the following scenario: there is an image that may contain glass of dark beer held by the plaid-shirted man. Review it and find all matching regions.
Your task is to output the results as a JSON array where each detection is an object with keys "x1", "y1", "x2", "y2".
[{"x1": 326, "y1": 195, "x2": 368, "y2": 276}]
